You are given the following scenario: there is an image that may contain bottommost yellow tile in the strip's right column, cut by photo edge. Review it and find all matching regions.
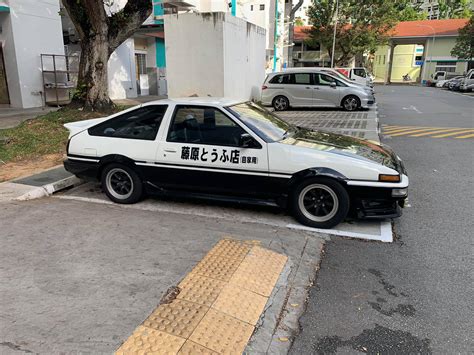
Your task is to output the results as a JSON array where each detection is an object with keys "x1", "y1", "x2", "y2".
[{"x1": 189, "y1": 309, "x2": 254, "y2": 354}]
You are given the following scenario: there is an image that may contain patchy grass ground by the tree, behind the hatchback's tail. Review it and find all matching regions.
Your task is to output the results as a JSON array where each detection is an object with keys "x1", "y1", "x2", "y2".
[{"x1": 0, "y1": 106, "x2": 126, "y2": 163}]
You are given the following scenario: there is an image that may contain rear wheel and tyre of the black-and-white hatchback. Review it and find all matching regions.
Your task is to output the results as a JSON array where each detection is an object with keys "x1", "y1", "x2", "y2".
[{"x1": 101, "y1": 164, "x2": 143, "y2": 204}]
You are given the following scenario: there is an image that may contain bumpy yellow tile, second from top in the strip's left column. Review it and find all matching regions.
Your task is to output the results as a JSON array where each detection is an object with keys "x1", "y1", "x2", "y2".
[{"x1": 191, "y1": 254, "x2": 242, "y2": 281}]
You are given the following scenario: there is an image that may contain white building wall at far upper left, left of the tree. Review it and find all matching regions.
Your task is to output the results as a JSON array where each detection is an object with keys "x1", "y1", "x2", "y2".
[{"x1": 2, "y1": 0, "x2": 64, "y2": 108}]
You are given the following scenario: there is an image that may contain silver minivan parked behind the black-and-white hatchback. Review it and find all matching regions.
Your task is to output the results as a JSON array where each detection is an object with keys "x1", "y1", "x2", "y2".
[{"x1": 261, "y1": 68, "x2": 375, "y2": 111}]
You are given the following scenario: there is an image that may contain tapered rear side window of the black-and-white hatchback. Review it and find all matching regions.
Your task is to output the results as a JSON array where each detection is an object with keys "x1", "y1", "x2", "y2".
[{"x1": 88, "y1": 105, "x2": 168, "y2": 141}]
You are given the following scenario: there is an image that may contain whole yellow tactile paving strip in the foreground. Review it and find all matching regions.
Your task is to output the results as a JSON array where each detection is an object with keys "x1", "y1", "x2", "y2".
[{"x1": 116, "y1": 239, "x2": 288, "y2": 355}]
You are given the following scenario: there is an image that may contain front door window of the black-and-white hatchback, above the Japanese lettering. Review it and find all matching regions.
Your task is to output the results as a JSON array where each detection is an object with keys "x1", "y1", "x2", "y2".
[{"x1": 167, "y1": 105, "x2": 246, "y2": 147}]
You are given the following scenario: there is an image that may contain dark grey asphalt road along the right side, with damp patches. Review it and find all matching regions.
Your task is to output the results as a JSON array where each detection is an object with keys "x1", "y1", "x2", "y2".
[{"x1": 291, "y1": 86, "x2": 474, "y2": 354}]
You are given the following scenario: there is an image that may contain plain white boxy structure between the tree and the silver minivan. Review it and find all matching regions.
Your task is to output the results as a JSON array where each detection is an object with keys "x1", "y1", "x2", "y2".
[{"x1": 164, "y1": 12, "x2": 265, "y2": 100}]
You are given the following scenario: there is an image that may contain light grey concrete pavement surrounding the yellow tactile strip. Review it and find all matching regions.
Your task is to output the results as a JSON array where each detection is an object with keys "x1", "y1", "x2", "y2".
[{"x1": 0, "y1": 198, "x2": 323, "y2": 353}]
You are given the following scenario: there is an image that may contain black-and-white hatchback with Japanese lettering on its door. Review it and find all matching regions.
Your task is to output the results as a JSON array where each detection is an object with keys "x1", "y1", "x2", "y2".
[{"x1": 64, "y1": 98, "x2": 408, "y2": 228}]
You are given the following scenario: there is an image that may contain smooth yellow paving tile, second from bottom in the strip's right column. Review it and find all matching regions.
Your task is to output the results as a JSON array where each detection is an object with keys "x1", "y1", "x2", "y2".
[{"x1": 212, "y1": 284, "x2": 268, "y2": 325}]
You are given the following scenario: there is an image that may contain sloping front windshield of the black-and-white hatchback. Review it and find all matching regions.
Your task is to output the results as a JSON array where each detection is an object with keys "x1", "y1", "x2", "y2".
[{"x1": 226, "y1": 102, "x2": 296, "y2": 142}]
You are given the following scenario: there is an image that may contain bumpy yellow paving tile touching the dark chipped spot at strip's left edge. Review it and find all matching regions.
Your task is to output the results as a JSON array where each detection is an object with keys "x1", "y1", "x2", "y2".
[{"x1": 177, "y1": 273, "x2": 226, "y2": 307}]
